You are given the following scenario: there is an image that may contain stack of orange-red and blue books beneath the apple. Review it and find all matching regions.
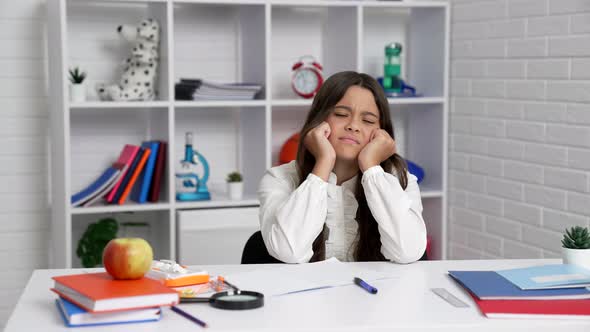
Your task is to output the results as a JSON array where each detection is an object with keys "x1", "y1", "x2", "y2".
[{"x1": 51, "y1": 272, "x2": 179, "y2": 326}]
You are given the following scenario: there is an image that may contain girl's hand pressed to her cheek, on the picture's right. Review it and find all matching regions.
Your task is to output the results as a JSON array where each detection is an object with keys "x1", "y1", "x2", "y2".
[{"x1": 358, "y1": 129, "x2": 397, "y2": 172}]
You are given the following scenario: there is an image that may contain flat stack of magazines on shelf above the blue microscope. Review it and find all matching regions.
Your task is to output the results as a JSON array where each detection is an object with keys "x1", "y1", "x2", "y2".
[{"x1": 175, "y1": 79, "x2": 262, "y2": 100}]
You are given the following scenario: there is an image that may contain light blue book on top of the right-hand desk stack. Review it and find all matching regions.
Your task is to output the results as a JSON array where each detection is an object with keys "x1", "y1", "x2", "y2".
[{"x1": 496, "y1": 264, "x2": 590, "y2": 289}]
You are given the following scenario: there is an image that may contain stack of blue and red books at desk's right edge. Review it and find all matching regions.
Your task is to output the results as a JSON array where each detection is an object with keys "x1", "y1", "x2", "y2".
[{"x1": 449, "y1": 264, "x2": 590, "y2": 320}]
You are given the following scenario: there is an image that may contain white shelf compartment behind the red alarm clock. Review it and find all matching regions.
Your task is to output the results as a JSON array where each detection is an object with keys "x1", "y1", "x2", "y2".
[{"x1": 271, "y1": 2, "x2": 358, "y2": 99}]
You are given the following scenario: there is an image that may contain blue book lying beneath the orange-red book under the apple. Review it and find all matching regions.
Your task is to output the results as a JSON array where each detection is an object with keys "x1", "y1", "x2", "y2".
[{"x1": 55, "y1": 297, "x2": 162, "y2": 327}]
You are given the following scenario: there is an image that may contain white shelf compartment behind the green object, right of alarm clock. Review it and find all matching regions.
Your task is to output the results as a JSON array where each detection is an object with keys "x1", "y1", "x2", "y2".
[{"x1": 361, "y1": 3, "x2": 446, "y2": 97}]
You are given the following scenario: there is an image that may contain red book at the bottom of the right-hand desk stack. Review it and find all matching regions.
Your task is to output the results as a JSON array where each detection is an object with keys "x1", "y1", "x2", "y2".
[{"x1": 471, "y1": 294, "x2": 590, "y2": 320}]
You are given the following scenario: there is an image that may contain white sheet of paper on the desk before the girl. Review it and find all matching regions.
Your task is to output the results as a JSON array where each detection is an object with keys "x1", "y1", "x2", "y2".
[{"x1": 225, "y1": 258, "x2": 396, "y2": 296}]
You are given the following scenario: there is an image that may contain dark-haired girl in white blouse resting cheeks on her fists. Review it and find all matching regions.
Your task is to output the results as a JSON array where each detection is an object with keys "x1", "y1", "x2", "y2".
[{"x1": 258, "y1": 71, "x2": 426, "y2": 263}]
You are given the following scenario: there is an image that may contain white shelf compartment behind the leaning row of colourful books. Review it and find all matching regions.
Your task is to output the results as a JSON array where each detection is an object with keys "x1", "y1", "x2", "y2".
[{"x1": 69, "y1": 108, "x2": 170, "y2": 205}]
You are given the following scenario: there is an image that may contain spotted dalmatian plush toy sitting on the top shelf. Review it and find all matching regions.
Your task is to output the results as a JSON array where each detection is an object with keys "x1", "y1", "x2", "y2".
[{"x1": 96, "y1": 18, "x2": 160, "y2": 101}]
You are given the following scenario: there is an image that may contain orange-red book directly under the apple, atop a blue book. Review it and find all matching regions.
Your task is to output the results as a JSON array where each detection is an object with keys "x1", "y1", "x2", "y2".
[{"x1": 51, "y1": 272, "x2": 178, "y2": 312}]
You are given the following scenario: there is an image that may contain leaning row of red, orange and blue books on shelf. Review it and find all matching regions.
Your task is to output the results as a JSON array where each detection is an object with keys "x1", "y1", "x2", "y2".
[{"x1": 71, "y1": 141, "x2": 167, "y2": 207}]
